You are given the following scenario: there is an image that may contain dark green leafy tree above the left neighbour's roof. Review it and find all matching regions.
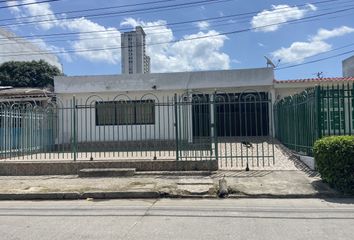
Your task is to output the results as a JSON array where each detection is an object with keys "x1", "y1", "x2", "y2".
[{"x1": 0, "y1": 60, "x2": 62, "y2": 88}]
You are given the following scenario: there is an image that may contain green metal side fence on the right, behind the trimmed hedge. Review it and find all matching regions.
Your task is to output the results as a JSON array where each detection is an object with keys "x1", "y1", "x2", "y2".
[{"x1": 274, "y1": 84, "x2": 354, "y2": 156}]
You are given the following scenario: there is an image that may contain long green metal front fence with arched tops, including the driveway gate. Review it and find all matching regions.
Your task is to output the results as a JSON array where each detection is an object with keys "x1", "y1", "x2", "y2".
[{"x1": 0, "y1": 91, "x2": 274, "y2": 168}]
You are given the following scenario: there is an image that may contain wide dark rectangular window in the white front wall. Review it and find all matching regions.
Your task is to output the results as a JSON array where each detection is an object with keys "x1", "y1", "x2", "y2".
[{"x1": 96, "y1": 100, "x2": 155, "y2": 126}]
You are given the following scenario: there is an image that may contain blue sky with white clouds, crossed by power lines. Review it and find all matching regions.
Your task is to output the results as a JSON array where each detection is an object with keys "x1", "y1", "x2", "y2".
[{"x1": 0, "y1": 0, "x2": 354, "y2": 80}]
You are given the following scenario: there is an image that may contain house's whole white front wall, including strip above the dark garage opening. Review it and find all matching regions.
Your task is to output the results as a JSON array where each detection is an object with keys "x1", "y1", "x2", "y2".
[{"x1": 57, "y1": 87, "x2": 271, "y2": 143}]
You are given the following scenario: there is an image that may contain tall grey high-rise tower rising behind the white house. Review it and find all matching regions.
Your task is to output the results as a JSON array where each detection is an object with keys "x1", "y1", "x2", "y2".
[{"x1": 121, "y1": 26, "x2": 150, "y2": 74}]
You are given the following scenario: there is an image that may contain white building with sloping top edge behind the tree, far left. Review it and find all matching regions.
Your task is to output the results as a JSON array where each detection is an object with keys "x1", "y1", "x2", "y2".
[{"x1": 0, "y1": 28, "x2": 63, "y2": 72}]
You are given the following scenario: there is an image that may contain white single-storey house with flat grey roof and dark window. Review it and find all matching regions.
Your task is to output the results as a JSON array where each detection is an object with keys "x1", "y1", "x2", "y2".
[{"x1": 54, "y1": 68, "x2": 274, "y2": 146}]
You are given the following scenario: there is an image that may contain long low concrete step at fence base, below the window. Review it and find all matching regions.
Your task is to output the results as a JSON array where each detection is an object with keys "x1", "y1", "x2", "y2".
[{"x1": 79, "y1": 168, "x2": 135, "y2": 177}]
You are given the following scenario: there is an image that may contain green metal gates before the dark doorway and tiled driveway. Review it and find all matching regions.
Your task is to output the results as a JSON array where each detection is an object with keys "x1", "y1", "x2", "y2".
[{"x1": 176, "y1": 91, "x2": 275, "y2": 169}]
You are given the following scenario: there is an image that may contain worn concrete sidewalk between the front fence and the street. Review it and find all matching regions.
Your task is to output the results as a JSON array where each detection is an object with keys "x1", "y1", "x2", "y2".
[{"x1": 0, "y1": 170, "x2": 341, "y2": 200}]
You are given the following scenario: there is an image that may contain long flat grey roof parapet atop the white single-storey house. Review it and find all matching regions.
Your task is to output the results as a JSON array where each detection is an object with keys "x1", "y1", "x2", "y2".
[{"x1": 54, "y1": 68, "x2": 274, "y2": 94}]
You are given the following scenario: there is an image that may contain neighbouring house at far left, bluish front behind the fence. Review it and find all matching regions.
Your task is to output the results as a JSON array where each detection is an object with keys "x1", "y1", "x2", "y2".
[{"x1": 0, "y1": 86, "x2": 54, "y2": 158}]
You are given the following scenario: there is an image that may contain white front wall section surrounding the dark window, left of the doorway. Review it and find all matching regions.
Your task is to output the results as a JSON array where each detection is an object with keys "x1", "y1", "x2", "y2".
[{"x1": 59, "y1": 93, "x2": 183, "y2": 143}]
